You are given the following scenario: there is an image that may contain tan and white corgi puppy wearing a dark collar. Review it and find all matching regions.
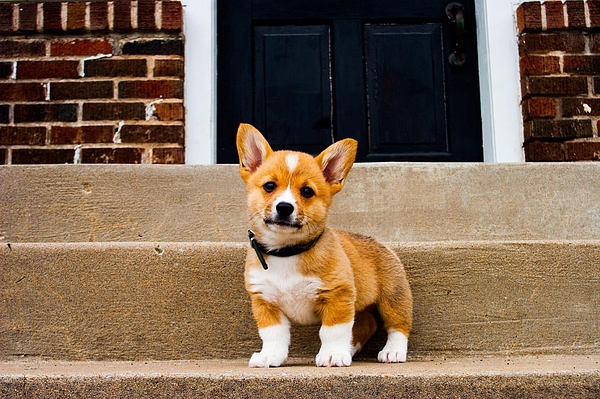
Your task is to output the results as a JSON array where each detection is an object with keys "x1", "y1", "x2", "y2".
[{"x1": 237, "y1": 124, "x2": 412, "y2": 367}]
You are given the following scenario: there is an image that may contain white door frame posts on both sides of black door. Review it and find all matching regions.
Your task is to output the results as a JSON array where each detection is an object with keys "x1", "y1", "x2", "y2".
[{"x1": 182, "y1": 0, "x2": 525, "y2": 164}]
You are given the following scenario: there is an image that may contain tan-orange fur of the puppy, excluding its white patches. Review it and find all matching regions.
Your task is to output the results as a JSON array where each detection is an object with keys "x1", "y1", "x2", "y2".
[{"x1": 237, "y1": 124, "x2": 412, "y2": 368}]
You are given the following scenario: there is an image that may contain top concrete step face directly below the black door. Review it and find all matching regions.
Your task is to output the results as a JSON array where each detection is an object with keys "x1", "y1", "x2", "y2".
[{"x1": 0, "y1": 163, "x2": 600, "y2": 243}]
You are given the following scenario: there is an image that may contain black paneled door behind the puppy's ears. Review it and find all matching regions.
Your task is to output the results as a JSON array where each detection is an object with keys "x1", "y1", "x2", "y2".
[{"x1": 217, "y1": 0, "x2": 483, "y2": 163}]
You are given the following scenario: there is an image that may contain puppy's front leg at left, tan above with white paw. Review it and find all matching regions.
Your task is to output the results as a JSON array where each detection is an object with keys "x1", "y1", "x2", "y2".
[{"x1": 248, "y1": 296, "x2": 291, "y2": 367}]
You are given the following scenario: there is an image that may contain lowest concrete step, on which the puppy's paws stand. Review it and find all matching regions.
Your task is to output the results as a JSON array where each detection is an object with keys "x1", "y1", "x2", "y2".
[{"x1": 0, "y1": 355, "x2": 600, "y2": 399}]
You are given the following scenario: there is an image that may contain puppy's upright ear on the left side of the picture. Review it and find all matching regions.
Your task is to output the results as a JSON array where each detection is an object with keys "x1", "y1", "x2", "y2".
[{"x1": 236, "y1": 123, "x2": 273, "y2": 181}]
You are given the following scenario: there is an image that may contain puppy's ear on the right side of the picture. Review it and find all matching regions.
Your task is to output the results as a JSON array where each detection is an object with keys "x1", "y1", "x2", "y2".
[{"x1": 316, "y1": 139, "x2": 358, "y2": 194}]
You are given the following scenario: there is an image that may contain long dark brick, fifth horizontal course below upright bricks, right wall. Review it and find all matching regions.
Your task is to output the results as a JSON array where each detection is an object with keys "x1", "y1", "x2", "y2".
[{"x1": 525, "y1": 119, "x2": 593, "y2": 141}]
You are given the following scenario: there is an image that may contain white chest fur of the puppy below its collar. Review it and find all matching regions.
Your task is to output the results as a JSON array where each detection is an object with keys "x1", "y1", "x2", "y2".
[{"x1": 248, "y1": 256, "x2": 321, "y2": 324}]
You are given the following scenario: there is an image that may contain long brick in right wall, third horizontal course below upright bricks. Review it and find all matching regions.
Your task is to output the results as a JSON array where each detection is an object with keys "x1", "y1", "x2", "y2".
[{"x1": 522, "y1": 76, "x2": 588, "y2": 97}]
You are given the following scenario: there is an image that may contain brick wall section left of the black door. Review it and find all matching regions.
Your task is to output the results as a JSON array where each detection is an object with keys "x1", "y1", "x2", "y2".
[{"x1": 0, "y1": 0, "x2": 184, "y2": 164}]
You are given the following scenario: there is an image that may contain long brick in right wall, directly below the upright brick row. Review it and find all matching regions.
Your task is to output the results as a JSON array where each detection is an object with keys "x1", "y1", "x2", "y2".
[{"x1": 520, "y1": 31, "x2": 585, "y2": 54}]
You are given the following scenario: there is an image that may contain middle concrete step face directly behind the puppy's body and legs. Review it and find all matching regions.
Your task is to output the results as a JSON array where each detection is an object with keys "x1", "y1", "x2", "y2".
[{"x1": 0, "y1": 241, "x2": 600, "y2": 360}]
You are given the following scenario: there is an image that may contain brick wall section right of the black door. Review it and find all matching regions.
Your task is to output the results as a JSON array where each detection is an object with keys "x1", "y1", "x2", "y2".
[{"x1": 517, "y1": 0, "x2": 600, "y2": 161}]
